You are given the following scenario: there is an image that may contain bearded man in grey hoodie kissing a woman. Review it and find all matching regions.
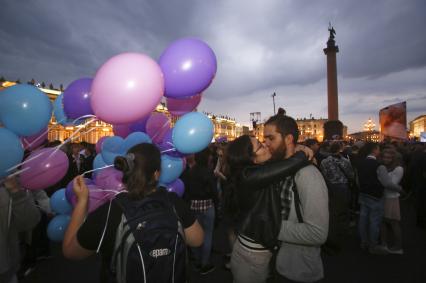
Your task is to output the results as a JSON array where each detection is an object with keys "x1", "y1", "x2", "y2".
[{"x1": 264, "y1": 115, "x2": 329, "y2": 282}]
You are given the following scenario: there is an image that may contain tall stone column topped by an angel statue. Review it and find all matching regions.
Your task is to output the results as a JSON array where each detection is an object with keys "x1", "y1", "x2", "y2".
[{"x1": 324, "y1": 25, "x2": 343, "y2": 140}]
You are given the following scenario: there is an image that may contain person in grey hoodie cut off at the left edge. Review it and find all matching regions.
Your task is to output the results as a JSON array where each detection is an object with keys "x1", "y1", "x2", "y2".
[{"x1": 0, "y1": 177, "x2": 40, "y2": 283}]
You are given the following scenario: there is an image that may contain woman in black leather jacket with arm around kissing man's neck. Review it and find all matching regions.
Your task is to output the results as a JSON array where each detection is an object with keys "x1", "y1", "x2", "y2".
[{"x1": 226, "y1": 135, "x2": 307, "y2": 282}]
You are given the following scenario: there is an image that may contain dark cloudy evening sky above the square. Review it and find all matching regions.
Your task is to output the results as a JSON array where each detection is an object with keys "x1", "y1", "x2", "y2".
[{"x1": 0, "y1": 0, "x2": 426, "y2": 132}]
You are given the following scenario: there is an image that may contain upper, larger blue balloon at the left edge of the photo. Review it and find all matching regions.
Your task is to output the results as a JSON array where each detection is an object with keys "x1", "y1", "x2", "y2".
[{"x1": 0, "y1": 84, "x2": 52, "y2": 136}]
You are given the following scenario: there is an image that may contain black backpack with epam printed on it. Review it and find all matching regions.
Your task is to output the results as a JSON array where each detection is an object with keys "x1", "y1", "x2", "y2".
[{"x1": 111, "y1": 190, "x2": 186, "y2": 283}]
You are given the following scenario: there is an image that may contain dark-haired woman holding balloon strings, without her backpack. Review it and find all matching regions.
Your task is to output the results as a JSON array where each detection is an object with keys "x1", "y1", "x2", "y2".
[{"x1": 62, "y1": 143, "x2": 203, "y2": 282}]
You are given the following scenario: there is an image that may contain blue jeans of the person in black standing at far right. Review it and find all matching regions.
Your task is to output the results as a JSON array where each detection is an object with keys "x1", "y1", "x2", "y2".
[{"x1": 358, "y1": 194, "x2": 384, "y2": 247}]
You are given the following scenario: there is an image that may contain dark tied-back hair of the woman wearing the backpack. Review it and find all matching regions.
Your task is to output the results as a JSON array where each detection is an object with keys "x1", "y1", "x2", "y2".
[{"x1": 114, "y1": 143, "x2": 161, "y2": 199}]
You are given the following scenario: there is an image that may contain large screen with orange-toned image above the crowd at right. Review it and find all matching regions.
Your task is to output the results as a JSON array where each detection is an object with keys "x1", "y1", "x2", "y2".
[{"x1": 379, "y1": 101, "x2": 407, "y2": 140}]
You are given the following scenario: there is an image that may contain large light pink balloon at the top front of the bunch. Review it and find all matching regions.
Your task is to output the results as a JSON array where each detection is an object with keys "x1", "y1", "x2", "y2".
[{"x1": 90, "y1": 53, "x2": 164, "y2": 124}]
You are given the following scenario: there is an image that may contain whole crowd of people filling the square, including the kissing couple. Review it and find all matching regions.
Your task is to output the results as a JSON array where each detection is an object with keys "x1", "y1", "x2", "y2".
[{"x1": 0, "y1": 113, "x2": 426, "y2": 283}]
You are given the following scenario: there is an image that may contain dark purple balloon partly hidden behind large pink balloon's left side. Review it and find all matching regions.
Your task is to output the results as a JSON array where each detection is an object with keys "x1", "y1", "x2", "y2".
[{"x1": 63, "y1": 78, "x2": 93, "y2": 119}]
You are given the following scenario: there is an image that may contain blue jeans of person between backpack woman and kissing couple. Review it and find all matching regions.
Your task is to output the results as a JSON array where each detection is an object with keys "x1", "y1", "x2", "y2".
[{"x1": 192, "y1": 207, "x2": 215, "y2": 266}]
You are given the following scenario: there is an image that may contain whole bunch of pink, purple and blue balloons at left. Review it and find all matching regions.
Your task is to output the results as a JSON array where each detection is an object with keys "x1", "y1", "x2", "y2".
[{"x1": 0, "y1": 38, "x2": 217, "y2": 241}]
